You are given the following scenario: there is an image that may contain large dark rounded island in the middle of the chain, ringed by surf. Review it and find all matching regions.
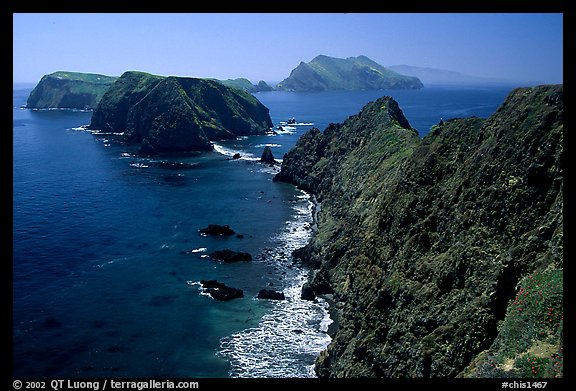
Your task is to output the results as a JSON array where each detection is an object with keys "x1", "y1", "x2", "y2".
[{"x1": 90, "y1": 72, "x2": 272, "y2": 153}]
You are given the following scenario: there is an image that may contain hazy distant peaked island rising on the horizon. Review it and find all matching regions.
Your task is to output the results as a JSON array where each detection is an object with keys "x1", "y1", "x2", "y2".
[{"x1": 276, "y1": 55, "x2": 423, "y2": 91}]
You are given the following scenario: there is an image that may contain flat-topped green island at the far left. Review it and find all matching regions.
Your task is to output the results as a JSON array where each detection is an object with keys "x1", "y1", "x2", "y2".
[{"x1": 26, "y1": 71, "x2": 117, "y2": 110}]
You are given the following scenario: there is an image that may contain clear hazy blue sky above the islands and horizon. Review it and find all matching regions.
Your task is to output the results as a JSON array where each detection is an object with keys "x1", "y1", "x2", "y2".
[{"x1": 13, "y1": 13, "x2": 563, "y2": 83}]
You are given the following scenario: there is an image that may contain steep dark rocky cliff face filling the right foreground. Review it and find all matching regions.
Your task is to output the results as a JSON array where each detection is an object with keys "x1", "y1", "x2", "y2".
[{"x1": 276, "y1": 85, "x2": 563, "y2": 377}]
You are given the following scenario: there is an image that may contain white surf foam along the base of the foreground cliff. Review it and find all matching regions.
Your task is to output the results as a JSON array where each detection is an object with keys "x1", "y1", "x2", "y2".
[{"x1": 218, "y1": 193, "x2": 332, "y2": 377}]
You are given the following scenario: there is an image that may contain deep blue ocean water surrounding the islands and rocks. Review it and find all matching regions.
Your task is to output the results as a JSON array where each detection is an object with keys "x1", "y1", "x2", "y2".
[{"x1": 13, "y1": 83, "x2": 510, "y2": 378}]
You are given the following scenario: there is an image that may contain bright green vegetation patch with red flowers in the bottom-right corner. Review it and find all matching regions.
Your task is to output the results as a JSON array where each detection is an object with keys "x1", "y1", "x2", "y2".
[{"x1": 467, "y1": 266, "x2": 564, "y2": 378}]
